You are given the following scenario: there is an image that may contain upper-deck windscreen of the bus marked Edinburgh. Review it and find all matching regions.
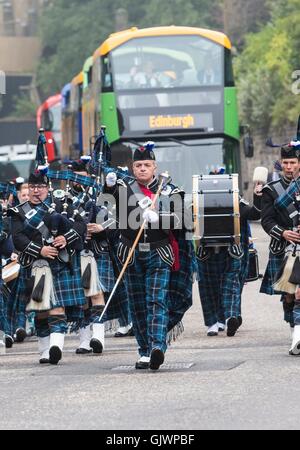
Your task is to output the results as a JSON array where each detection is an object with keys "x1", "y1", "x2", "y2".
[{"x1": 110, "y1": 35, "x2": 224, "y2": 91}]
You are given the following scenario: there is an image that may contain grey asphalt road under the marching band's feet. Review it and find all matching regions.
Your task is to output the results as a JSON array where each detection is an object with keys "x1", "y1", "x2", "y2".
[{"x1": 0, "y1": 224, "x2": 300, "y2": 430}]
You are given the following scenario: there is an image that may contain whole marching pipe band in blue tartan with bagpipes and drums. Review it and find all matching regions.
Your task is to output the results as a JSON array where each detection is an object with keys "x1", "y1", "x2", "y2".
[{"x1": 0, "y1": 120, "x2": 300, "y2": 371}]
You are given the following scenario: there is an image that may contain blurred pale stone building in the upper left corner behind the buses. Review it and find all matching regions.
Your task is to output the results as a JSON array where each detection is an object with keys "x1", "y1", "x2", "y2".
[{"x1": 0, "y1": 0, "x2": 48, "y2": 146}]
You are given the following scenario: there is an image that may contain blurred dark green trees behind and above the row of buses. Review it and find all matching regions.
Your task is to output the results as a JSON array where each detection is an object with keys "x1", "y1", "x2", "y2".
[{"x1": 37, "y1": 0, "x2": 221, "y2": 96}]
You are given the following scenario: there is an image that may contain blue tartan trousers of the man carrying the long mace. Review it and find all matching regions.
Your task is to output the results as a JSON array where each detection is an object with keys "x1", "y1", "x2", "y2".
[{"x1": 126, "y1": 250, "x2": 171, "y2": 356}]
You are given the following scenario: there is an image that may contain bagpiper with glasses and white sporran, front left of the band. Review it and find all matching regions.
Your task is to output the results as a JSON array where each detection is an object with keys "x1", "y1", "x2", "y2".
[{"x1": 9, "y1": 172, "x2": 86, "y2": 364}]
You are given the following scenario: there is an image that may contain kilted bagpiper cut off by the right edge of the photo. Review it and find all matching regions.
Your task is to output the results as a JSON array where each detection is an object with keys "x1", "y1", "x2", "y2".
[{"x1": 260, "y1": 125, "x2": 300, "y2": 355}]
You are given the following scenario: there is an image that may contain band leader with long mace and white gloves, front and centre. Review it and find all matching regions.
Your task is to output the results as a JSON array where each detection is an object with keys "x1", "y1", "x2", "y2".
[{"x1": 102, "y1": 143, "x2": 192, "y2": 370}]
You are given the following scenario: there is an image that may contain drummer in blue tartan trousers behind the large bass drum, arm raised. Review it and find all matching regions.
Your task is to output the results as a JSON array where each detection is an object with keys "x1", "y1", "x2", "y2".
[{"x1": 197, "y1": 169, "x2": 262, "y2": 337}]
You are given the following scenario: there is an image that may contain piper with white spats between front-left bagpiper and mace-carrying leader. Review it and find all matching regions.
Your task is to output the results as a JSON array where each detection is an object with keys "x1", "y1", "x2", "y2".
[{"x1": 71, "y1": 159, "x2": 115, "y2": 355}]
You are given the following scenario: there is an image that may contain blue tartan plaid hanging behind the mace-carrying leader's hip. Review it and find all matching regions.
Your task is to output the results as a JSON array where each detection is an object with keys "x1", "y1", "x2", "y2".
[{"x1": 168, "y1": 236, "x2": 196, "y2": 331}]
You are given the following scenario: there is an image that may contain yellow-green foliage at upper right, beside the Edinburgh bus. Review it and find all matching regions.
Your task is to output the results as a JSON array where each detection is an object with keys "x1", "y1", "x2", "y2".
[{"x1": 235, "y1": 0, "x2": 300, "y2": 133}]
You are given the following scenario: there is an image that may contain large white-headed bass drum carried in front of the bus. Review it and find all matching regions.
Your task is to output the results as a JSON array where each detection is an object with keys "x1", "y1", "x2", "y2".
[{"x1": 193, "y1": 174, "x2": 241, "y2": 247}]
